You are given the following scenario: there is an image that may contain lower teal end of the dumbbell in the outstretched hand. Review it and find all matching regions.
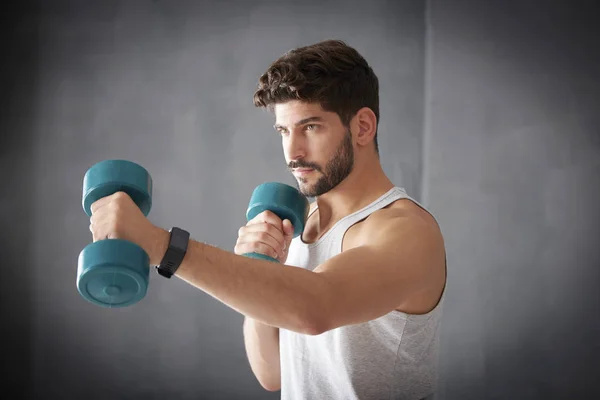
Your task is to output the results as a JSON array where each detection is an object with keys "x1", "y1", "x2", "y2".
[{"x1": 77, "y1": 239, "x2": 150, "y2": 308}]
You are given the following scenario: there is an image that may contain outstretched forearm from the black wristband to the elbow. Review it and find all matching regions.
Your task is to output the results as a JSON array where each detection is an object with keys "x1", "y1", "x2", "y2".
[{"x1": 169, "y1": 240, "x2": 328, "y2": 334}]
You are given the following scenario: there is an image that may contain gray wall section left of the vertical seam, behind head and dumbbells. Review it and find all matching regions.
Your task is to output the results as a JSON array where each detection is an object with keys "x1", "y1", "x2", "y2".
[{"x1": 0, "y1": 0, "x2": 425, "y2": 399}]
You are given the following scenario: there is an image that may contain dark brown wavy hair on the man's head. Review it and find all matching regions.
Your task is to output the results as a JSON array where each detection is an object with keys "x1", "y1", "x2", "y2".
[{"x1": 254, "y1": 40, "x2": 379, "y2": 153}]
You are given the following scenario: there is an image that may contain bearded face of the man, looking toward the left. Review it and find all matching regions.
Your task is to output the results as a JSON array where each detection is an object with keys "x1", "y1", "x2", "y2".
[{"x1": 275, "y1": 100, "x2": 354, "y2": 197}]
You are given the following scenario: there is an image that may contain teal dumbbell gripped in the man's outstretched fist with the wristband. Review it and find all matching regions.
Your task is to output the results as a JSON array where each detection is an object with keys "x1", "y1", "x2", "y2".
[{"x1": 77, "y1": 160, "x2": 152, "y2": 308}]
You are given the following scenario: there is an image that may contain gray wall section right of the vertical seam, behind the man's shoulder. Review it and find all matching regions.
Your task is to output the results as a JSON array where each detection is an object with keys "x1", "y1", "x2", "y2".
[{"x1": 423, "y1": 0, "x2": 600, "y2": 400}]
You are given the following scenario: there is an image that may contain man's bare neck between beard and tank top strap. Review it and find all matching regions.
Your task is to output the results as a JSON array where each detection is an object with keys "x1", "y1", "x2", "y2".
[{"x1": 316, "y1": 160, "x2": 394, "y2": 230}]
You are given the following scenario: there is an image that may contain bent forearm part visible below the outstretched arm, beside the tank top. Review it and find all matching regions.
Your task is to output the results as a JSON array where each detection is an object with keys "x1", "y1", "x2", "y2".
[{"x1": 244, "y1": 317, "x2": 281, "y2": 390}]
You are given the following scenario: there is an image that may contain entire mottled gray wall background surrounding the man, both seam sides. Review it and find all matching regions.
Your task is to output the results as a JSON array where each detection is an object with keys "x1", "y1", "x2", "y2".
[{"x1": 0, "y1": 0, "x2": 600, "y2": 399}]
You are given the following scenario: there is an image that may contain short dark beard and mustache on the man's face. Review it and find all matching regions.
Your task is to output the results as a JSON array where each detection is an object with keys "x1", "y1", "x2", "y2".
[{"x1": 288, "y1": 130, "x2": 354, "y2": 197}]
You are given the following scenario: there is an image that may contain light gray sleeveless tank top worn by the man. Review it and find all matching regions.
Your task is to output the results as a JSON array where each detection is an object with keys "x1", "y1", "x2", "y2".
[{"x1": 279, "y1": 187, "x2": 445, "y2": 400}]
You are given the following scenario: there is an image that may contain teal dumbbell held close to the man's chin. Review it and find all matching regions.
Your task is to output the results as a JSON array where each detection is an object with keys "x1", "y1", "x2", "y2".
[{"x1": 244, "y1": 182, "x2": 310, "y2": 262}]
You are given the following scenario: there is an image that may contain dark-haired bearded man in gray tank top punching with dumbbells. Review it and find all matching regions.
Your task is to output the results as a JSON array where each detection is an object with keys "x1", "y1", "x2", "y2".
[{"x1": 90, "y1": 41, "x2": 446, "y2": 399}]
